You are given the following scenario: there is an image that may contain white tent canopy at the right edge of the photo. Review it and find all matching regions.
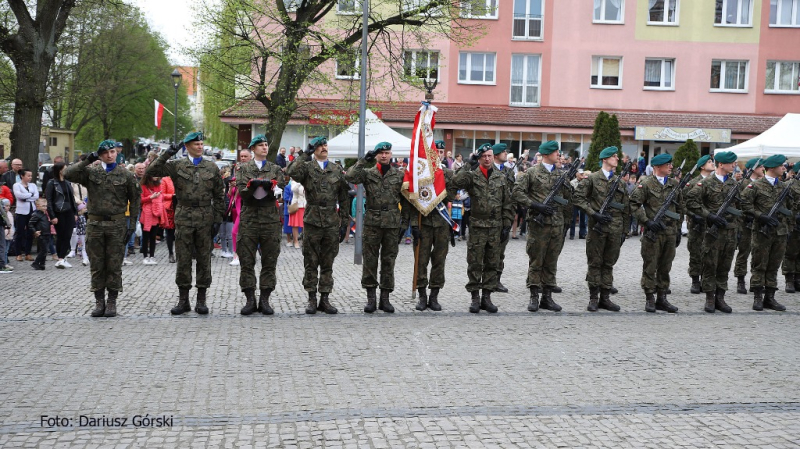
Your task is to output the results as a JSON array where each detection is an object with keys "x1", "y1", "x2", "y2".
[{"x1": 715, "y1": 114, "x2": 800, "y2": 160}]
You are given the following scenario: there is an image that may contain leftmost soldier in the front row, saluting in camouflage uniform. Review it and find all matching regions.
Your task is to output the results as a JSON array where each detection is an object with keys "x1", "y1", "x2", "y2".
[{"x1": 64, "y1": 140, "x2": 142, "y2": 317}]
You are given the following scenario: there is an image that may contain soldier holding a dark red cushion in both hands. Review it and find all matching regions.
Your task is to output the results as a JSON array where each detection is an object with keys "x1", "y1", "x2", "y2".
[{"x1": 236, "y1": 134, "x2": 286, "y2": 315}]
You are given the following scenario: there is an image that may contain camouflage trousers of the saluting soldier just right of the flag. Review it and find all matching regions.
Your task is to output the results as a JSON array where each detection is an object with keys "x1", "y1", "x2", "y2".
[{"x1": 466, "y1": 226, "x2": 500, "y2": 292}]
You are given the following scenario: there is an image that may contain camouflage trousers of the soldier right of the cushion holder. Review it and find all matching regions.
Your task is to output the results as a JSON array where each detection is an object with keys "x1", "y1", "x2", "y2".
[{"x1": 303, "y1": 223, "x2": 338, "y2": 293}]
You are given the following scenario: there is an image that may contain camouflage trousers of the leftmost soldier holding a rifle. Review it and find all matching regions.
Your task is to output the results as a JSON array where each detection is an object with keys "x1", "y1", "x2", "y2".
[{"x1": 525, "y1": 221, "x2": 565, "y2": 288}]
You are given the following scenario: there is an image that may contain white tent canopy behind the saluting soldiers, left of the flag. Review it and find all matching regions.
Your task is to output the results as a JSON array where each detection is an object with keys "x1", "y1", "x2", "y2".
[{"x1": 328, "y1": 109, "x2": 411, "y2": 159}]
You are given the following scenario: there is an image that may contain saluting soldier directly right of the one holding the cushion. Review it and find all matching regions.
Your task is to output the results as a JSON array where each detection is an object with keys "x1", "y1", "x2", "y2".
[{"x1": 286, "y1": 137, "x2": 352, "y2": 314}]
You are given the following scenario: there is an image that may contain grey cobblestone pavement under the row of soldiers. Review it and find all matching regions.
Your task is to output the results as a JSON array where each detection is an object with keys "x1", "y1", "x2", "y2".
[{"x1": 0, "y1": 234, "x2": 800, "y2": 448}]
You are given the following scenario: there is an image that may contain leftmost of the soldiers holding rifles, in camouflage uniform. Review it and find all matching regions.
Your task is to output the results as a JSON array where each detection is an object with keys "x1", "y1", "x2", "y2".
[{"x1": 514, "y1": 140, "x2": 572, "y2": 312}]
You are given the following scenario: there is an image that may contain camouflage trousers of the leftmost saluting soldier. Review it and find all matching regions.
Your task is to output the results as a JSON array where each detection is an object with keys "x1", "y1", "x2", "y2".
[{"x1": 86, "y1": 220, "x2": 128, "y2": 292}]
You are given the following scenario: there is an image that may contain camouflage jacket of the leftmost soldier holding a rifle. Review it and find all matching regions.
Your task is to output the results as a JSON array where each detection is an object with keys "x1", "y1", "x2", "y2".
[{"x1": 514, "y1": 163, "x2": 572, "y2": 226}]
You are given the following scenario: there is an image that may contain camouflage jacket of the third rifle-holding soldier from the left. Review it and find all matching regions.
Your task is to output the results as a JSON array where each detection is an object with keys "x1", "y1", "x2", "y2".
[{"x1": 631, "y1": 175, "x2": 685, "y2": 235}]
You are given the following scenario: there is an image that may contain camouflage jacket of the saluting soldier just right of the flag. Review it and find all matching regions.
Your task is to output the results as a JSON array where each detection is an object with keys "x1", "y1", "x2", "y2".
[{"x1": 450, "y1": 164, "x2": 514, "y2": 228}]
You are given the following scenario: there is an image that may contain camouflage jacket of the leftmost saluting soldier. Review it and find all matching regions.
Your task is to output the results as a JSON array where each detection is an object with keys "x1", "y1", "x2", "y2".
[{"x1": 64, "y1": 161, "x2": 142, "y2": 216}]
